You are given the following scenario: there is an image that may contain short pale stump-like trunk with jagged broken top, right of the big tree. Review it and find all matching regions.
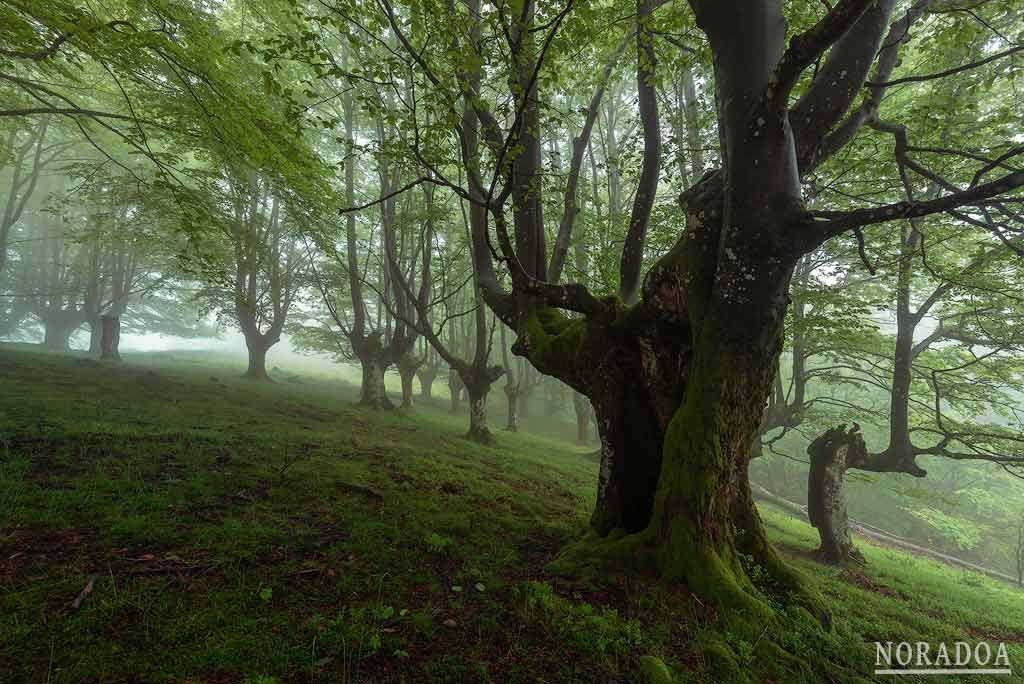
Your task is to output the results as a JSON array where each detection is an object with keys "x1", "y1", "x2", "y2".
[{"x1": 807, "y1": 425, "x2": 867, "y2": 564}]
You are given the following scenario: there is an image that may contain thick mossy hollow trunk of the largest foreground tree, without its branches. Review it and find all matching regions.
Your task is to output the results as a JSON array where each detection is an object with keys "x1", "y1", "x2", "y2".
[{"x1": 513, "y1": 166, "x2": 821, "y2": 637}]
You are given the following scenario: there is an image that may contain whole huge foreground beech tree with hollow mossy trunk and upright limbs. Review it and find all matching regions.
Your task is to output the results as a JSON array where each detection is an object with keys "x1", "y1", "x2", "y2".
[{"x1": 323, "y1": 0, "x2": 1024, "y2": 643}]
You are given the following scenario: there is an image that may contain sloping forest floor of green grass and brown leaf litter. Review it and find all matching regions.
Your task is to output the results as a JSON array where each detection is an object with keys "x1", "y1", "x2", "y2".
[{"x1": 0, "y1": 347, "x2": 1024, "y2": 684}]
